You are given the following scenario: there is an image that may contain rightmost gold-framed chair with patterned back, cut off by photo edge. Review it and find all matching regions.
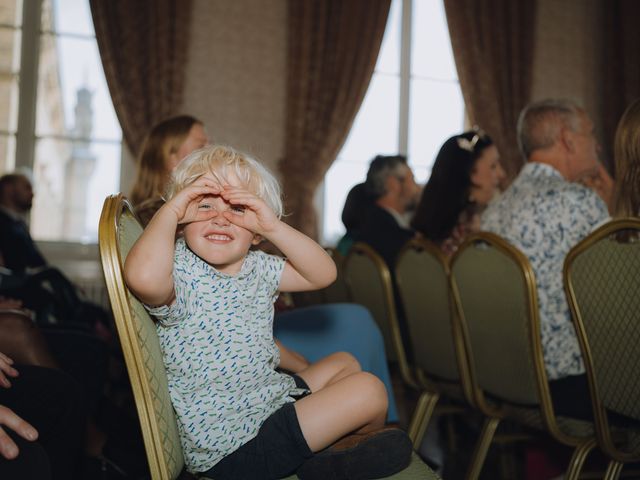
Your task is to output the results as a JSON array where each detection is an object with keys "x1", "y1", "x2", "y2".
[{"x1": 564, "y1": 218, "x2": 640, "y2": 480}]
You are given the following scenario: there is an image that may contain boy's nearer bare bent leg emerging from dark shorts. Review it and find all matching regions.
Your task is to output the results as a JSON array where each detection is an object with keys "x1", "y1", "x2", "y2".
[{"x1": 295, "y1": 372, "x2": 387, "y2": 452}]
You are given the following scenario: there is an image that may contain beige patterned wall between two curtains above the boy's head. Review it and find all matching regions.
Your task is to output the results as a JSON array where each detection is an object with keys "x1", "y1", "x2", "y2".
[{"x1": 183, "y1": 0, "x2": 286, "y2": 173}]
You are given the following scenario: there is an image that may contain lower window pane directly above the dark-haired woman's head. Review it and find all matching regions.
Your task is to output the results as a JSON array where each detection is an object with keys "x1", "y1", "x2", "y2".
[{"x1": 409, "y1": 79, "x2": 464, "y2": 183}]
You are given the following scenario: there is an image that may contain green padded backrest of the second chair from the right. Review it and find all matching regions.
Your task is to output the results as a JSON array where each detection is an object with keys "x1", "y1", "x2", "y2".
[{"x1": 451, "y1": 232, "x2": 550, "y2": 414}]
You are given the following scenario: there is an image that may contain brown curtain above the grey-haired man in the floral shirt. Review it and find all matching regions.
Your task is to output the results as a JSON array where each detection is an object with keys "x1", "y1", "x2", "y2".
[{"x1": 444, "y1": 0, "x2": 536, "y2": 181}]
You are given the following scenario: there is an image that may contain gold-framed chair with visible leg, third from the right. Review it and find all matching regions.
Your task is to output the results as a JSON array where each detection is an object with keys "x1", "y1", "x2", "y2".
[{"x1": 395, "y1": 239, "x2": 471, "y2": 446}]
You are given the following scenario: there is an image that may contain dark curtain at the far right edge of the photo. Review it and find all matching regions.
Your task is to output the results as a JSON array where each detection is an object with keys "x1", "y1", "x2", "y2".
[{"x1": 602, "y1": 0, "x2": 640, "y2": 174}]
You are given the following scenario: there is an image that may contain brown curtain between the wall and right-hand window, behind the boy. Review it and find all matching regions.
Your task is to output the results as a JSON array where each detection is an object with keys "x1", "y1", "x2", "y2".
[{"x1": 279, "y1": 0, "x2": 390, "y2": 238}]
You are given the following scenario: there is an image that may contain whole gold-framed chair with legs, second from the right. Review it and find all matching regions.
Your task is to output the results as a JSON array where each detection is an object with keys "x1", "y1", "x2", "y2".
[{"x1": 451, "y1": 232, "x2": 595, "y2": 480}]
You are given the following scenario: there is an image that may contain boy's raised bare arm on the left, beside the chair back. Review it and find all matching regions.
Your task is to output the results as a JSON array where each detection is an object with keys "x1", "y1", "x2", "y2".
[{"x1": 124, "y1": 180, "x2": 220, "y2": 306}]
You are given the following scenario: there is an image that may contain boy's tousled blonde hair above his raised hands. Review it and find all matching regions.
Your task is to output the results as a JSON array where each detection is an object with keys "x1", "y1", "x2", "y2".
[{"x1": 166, "y1": 145, "x2": 283, "y2": 218}]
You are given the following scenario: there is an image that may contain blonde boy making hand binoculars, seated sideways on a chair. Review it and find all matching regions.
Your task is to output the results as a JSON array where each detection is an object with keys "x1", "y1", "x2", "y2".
[{"x1": 125, "y1": 146, "x2": 411, "y2": 479}]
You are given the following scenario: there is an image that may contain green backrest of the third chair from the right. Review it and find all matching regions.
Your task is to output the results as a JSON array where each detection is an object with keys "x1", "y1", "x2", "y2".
[{"x1": 395, "y1": 239, "x2": 460, "y2": 381}]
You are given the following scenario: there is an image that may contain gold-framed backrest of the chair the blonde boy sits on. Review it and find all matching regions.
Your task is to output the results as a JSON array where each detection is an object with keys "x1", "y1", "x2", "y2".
[{"x1": 98, "y1": 194, "x2": 184, "y2": 480}]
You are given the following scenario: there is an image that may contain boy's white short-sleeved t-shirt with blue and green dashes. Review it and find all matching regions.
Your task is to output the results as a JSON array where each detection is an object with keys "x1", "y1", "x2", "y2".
[{"x1": 148, "y1": 239, "x2": 301, "y2": 472}]
